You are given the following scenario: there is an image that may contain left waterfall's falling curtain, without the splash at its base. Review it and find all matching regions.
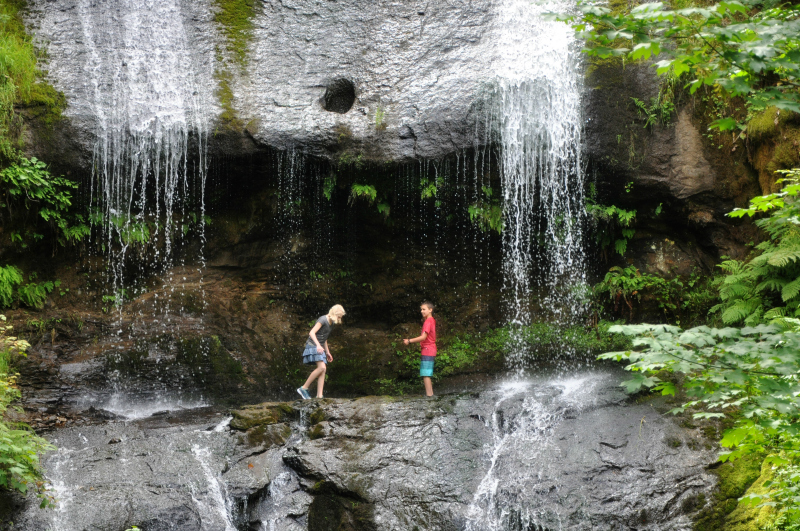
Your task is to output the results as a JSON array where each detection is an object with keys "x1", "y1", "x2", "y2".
[{"x1": 76, "y1": 0, "x2": 209, "y2": 305}]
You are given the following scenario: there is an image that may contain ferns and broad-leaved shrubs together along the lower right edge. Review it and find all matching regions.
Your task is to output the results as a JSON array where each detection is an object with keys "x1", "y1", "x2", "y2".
[{"x1": 601, "y1": 170, "x2": 800, "y2": 530}]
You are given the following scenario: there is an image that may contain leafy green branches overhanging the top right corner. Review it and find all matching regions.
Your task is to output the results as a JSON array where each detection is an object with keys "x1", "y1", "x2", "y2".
[{"x1": 556, "y1": 1, "x2": 800, "y2": 130}]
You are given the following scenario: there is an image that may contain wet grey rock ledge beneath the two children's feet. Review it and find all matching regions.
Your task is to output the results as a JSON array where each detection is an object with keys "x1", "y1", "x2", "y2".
[{"x1": 7, "y1": 371, "x2": 714, "y2": 531}]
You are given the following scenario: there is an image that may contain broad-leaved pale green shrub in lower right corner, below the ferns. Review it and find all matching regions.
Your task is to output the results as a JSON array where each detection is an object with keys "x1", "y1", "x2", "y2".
[{"x1": 600, "y1": 324, "x2": 800, "y2": 529}]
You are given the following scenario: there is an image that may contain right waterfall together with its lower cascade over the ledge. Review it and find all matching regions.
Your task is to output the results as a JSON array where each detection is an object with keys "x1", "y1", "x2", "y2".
[{"x1": 466, "y1": 0, "x2": 592, "y2": 531}]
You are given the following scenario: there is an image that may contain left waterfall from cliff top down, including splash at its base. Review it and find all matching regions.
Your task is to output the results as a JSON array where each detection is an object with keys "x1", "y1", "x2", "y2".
[{"x1": 69, "y1": 0, "x2": 215, "y2": 424}]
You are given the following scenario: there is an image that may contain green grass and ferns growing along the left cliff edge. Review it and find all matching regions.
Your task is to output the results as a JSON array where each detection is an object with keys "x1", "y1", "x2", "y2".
[{"x1": 0, "y1": 0, "x2": 84, "y2": 308}]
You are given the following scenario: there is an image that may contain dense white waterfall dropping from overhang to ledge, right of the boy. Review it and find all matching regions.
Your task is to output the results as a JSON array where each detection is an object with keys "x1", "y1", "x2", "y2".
[{"x1": 493, "y1": 0, "x2": 585, "y2": 369}]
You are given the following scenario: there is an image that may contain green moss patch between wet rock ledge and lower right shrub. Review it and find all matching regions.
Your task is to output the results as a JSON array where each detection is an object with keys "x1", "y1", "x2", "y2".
[{"x1": 694, "y1": 455, "x2": 764, "y2": 531}]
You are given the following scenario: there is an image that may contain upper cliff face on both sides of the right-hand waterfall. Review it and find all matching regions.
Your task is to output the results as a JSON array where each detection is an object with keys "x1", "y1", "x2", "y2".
[{"x1": 21, "y1": 0, "x2": 764, "y2": 275}]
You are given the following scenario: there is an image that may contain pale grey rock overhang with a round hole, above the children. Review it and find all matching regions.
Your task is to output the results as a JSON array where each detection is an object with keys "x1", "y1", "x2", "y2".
[{"x1": 23, "y1": 0, "x2": 497, "y2": 164}]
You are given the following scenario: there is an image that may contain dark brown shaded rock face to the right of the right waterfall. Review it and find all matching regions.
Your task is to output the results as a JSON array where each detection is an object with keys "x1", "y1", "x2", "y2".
[{"x1": 585, "y1": 61, "x2": 760, "y2": 276}]
